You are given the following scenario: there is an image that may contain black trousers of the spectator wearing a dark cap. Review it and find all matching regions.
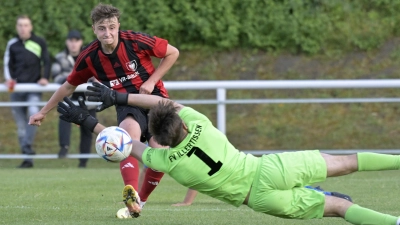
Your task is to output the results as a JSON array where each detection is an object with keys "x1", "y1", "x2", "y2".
[{"x1": 58, "y1": 109, "x2": 96, "y2": 165}]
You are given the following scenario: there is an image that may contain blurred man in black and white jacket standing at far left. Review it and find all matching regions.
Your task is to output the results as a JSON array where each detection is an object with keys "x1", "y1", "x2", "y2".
[{"x1": 4, "y1": 15, "x2": 51, "y2": 168}]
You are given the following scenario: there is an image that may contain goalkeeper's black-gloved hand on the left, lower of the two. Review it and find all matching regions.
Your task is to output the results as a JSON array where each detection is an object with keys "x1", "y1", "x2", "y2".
[{"x1": 57, "y1": 97, "x2": 98, "y2": 132}]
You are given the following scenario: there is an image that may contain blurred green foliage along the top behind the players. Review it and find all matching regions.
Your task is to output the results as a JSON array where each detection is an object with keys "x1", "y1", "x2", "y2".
[{"x1": 0, "y1": 0, "x2": 400, "y2": 54}]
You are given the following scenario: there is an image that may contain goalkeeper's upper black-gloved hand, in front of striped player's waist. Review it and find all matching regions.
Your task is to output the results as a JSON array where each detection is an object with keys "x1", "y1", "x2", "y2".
[{"x1": 85, "y1": 82, "x2": 129, "y2": 112}]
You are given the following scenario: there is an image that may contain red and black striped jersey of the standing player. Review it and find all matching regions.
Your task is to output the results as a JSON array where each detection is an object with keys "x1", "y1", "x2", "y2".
[{"x1": 67, "y1": 30, "x2": 168, "y2": 98}]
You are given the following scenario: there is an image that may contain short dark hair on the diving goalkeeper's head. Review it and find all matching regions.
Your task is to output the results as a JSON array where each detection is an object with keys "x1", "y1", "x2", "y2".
[{"x1": 149, "y1": 100, "x2": 184, "y2": 147}]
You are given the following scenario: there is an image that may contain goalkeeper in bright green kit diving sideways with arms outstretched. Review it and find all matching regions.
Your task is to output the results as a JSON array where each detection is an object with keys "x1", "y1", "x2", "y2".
[{"x1": 58, "y1": 83, "x2": 400, "y2": 225}]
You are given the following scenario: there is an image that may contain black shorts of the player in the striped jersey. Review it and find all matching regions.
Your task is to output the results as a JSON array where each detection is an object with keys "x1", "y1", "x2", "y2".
[{"x1": 115, "y1": 105, "x2": 152, "y2": 142}]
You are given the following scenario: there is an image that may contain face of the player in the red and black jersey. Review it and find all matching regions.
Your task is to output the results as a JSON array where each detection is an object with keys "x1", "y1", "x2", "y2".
[{"x1": 92, "y1": 17, "x2": 119, "y2": 45}]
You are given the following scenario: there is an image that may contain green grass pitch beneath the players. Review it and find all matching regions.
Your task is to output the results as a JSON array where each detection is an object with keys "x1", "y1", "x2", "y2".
[{"x1": 0, "y1": 159, "x2": 400, "y2": 225}]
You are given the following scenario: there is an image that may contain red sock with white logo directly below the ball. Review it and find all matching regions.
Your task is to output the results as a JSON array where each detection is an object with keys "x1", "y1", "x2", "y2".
[{"x1": 119, "y1": 156, "x2": 139, "y2": 190}]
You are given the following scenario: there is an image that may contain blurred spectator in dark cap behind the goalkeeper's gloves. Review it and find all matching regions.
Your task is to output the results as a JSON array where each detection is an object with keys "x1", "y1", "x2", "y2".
[{"x1": 51, "y1": 30, "x2": 96, "y2": 167}]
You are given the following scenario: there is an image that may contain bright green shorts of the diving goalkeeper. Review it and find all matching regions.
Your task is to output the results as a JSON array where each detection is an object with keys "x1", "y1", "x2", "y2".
[{"x1": 248, "y1": 150, "x2": 327, "y2": 219}]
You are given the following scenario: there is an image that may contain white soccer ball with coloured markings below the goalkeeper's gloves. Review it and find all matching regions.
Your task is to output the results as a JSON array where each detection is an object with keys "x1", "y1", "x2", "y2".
[{"x1": 96, "y1": 126, "x2": 132, "y2": 162}]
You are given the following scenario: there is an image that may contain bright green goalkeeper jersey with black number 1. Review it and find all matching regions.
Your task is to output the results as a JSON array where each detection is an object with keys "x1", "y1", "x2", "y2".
[{"x1": 142, "y1": 107, "x2": 260, "y2": 206}]
